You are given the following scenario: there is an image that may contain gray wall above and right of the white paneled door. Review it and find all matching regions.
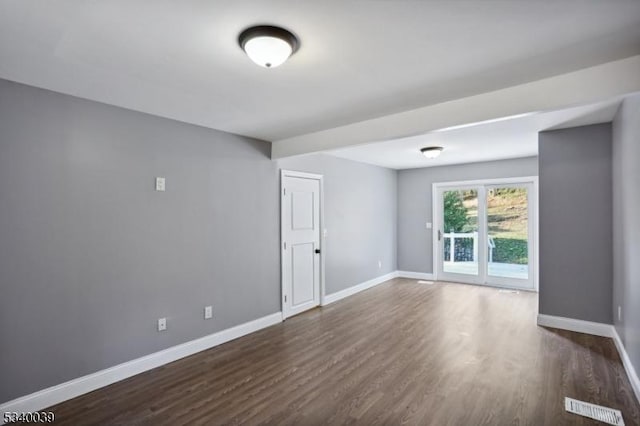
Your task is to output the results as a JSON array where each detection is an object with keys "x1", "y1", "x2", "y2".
[{"x1": 278, "y1": 154, "x2": 398, "y2": 294}]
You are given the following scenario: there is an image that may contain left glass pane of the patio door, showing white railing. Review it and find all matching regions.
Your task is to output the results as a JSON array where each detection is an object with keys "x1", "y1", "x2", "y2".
[{"x1": 442, "y1": 188, "x2": 478, "y2": 275}]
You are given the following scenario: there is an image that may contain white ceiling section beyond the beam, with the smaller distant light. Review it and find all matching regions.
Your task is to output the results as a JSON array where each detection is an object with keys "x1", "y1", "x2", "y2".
[{"x1": 328, "y1": 98, "x2": 621, "y2": 169}]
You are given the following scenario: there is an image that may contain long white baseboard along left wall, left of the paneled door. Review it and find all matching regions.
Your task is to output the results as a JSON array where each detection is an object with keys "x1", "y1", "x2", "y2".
[{"x1": 0, "y1": 312, "x2": 282, "y2": 424}]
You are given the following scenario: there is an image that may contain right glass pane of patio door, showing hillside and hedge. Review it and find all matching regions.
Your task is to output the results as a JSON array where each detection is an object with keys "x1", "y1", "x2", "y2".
[{"x1": 487, "y1": 186, "x2": 529, "y2": 279}]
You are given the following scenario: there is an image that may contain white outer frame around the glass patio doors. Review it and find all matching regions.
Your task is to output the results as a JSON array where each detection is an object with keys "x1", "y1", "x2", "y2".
[{"x1": 431, "y1": 176, "x2": 540, "y2": 292}]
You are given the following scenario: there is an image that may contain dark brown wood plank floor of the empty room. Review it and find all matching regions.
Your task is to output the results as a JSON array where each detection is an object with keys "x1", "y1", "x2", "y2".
[{"x1": 41, "y1": 279, "x2": 640, "y2": 425}]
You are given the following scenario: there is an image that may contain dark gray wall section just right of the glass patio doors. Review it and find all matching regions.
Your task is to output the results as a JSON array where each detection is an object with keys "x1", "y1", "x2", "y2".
[{"x1": 538, "y1": 123, "x2": 613, "y2": 324}]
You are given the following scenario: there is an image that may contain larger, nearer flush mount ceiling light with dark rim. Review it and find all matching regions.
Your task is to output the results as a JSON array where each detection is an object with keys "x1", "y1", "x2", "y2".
[{"x1": 238, "y1": 25, "x2": 299, "y2": 68}]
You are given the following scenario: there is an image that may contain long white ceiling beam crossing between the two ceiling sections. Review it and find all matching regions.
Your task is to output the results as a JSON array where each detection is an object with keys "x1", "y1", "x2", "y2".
[{"x1": 271, "y1": 55, "x2": 640, "y2": 159}]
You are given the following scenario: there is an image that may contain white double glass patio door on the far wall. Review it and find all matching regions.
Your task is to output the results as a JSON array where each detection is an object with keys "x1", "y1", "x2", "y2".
[{"x1": 434, "y1": 178, "x2": 537, "y2": 290}]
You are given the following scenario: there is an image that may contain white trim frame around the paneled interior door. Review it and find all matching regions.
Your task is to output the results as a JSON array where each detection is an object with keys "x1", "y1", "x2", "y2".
[{"x1": 280, "y1": 169, "x2": 325, "y2": 321}]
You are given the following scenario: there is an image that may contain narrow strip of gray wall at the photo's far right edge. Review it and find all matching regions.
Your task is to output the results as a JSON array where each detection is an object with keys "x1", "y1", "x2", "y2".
[{"x1": 613, "y1": 95, "x2": 640, "y2": 371}]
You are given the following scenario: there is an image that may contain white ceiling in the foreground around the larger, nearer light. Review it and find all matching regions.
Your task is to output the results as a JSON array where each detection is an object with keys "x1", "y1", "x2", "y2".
[{"x1": 0, "y1": 0, "x2": 640, "y2": 145}]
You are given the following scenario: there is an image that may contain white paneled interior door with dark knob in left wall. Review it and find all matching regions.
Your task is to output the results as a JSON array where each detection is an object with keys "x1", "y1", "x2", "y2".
[{"x1": 281, "y1": 171, "x2": 322, "y2": 318}]
